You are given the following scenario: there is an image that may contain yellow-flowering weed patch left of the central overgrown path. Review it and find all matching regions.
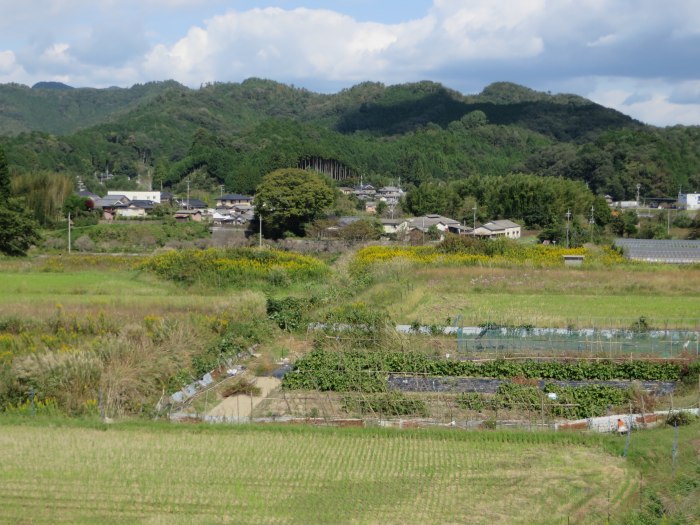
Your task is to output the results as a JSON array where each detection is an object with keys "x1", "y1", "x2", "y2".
[{"x1": 143, "y1": 248, "x2": 329, "y2": 287}]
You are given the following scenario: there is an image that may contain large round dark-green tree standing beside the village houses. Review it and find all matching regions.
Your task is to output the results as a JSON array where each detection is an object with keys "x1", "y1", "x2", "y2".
[{"x1": 255, "y1": 168, "x2": 336, "y2": 238}]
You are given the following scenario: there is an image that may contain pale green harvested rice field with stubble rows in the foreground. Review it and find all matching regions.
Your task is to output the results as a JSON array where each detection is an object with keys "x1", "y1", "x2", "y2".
[{"x1": 0, "y1": 424, "x2": 637, "y2": 524}]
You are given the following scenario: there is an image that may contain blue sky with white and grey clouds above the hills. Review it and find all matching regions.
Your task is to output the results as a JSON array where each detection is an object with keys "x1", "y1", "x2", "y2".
[{"x1": 0, "y1": 0, "x2": 700, "y2": 126}]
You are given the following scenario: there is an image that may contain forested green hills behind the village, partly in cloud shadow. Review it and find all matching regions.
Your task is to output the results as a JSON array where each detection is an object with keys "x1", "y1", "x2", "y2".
[{"x1": 0, "y1": 78, "x2": 700, "y2": 200}]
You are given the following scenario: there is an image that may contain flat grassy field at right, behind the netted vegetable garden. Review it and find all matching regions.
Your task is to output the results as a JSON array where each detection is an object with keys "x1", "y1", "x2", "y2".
[{"x1": 360, "y1": 266, "x2": 700, "y2": 328}]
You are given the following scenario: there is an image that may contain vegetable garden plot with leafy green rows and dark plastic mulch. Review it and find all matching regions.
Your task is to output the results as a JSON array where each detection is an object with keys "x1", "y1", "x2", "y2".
[{"x1": 278, "y1": 349, "x2": 697, "y2": 425}]
